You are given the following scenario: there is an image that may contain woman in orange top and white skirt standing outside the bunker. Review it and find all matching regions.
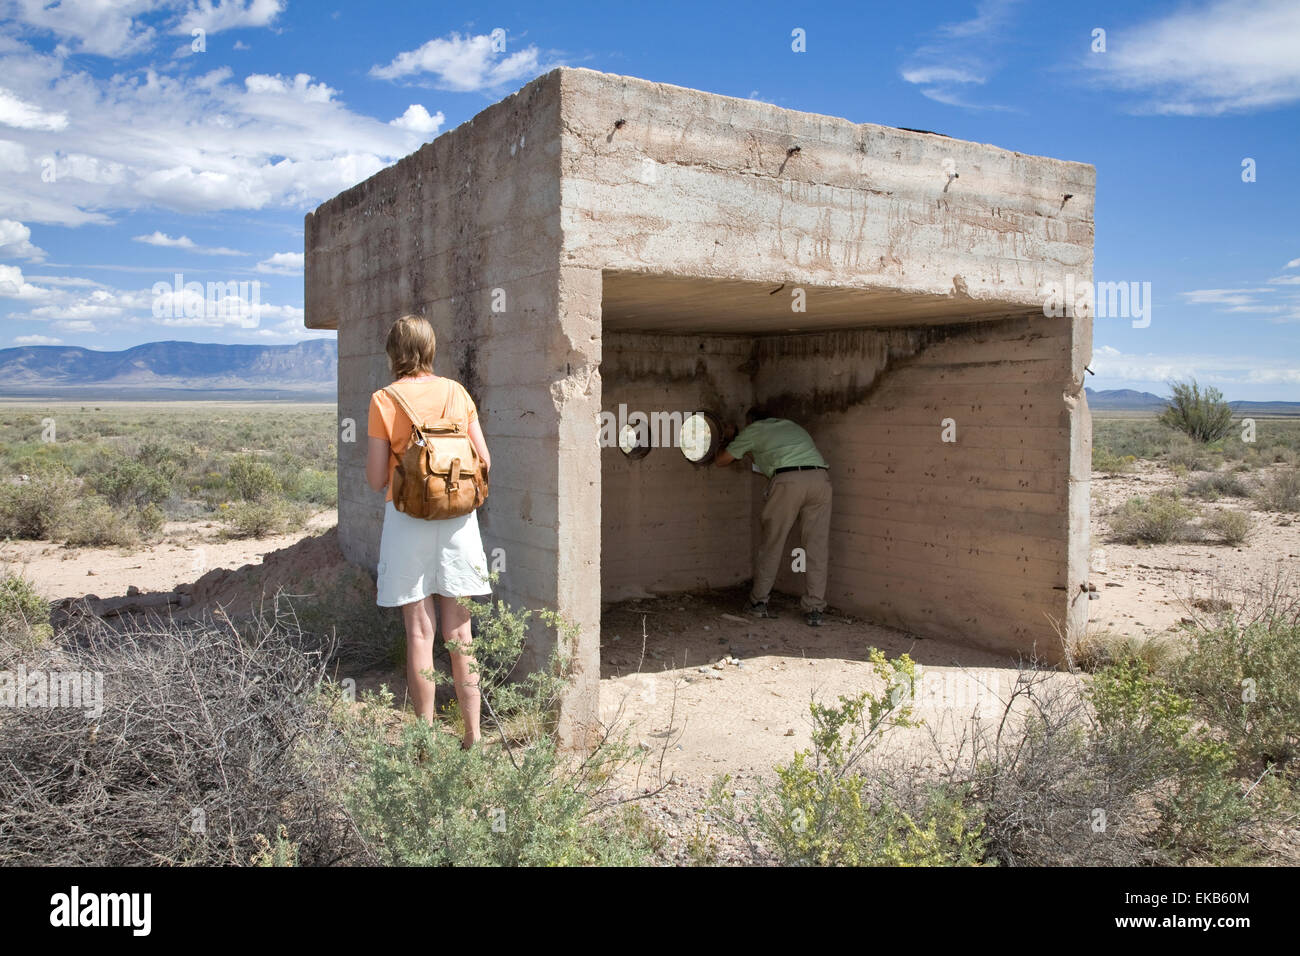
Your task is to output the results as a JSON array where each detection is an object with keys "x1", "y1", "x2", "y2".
[{"x1": 365, "y1": 315, "x2": 491, "y2": 749}]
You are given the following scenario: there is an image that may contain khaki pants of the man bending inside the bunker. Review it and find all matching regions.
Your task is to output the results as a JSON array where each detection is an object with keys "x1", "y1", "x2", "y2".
[{"x1": 749, "y1": 468, "x2": 831, "y2": 611}]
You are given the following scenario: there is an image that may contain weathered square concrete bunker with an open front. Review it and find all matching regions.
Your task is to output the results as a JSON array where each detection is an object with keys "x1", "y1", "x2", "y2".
[{"x1": 307, "y1": 68, "x2": 1095, "y2": 741}]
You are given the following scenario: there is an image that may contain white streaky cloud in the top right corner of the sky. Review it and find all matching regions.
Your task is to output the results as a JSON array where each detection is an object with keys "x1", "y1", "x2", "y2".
[{"x1": 1084, "y1": 0, "x2": 1300, "y2": 116}]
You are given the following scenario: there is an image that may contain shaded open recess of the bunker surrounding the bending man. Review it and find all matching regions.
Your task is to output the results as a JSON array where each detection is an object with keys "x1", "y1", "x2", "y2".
[{"x1": 599, "y1": 269, "x2": 1070, "y2": 658}]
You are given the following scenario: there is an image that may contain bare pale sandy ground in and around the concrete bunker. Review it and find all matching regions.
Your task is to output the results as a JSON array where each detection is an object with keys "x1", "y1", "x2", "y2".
[{"x1": 0, "y1": 463, "x2": 1300, "y2": 862}]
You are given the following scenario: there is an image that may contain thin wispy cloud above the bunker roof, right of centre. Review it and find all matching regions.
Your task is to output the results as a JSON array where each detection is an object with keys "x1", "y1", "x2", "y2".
[{"x1": 898, "y1": 0, "x2": 1019, "y2": 111}]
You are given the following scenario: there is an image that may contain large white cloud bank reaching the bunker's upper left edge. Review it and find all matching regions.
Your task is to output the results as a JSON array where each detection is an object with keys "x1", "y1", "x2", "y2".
[{"x1": 0, "y1": 55, "x2": 443, "y2": 226}]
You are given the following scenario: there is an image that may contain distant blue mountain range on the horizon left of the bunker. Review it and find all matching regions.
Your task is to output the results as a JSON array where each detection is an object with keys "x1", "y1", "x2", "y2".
[{"x1": 0, "y1": 338, "x2": 338, "y2": 401}]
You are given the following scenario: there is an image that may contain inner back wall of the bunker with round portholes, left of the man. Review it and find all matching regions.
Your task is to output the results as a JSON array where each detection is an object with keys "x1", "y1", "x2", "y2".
[{"x1": 601, "y1": 332, "x2": 755, "y2": 601}]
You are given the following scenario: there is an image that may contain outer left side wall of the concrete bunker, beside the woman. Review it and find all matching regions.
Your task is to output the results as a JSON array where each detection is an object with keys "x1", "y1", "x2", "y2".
[{"x1": 306, "y1": 67, "x2": 585, "y2": 733}]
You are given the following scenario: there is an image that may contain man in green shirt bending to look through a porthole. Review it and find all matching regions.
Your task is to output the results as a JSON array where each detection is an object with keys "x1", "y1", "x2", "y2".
[{"x1": 714, "y1": 406, "x2": 831, "y2": 627}]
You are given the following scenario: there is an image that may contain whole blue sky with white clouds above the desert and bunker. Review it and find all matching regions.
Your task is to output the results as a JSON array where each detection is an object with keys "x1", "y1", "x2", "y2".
[{"x1": 0, "y1": 0, "x2": 1300, "y2": 401}]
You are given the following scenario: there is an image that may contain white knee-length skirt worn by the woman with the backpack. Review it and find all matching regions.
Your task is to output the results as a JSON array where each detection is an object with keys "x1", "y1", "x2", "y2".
[{"x1": 374, "y1": 501, "x2": 491, "y2": 607}]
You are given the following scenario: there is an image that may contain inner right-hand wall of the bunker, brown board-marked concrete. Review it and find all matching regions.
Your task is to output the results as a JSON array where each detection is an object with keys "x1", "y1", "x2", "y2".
[{"x1": 758, "y1": 316, "x2": 1091, "y2": 659}]
